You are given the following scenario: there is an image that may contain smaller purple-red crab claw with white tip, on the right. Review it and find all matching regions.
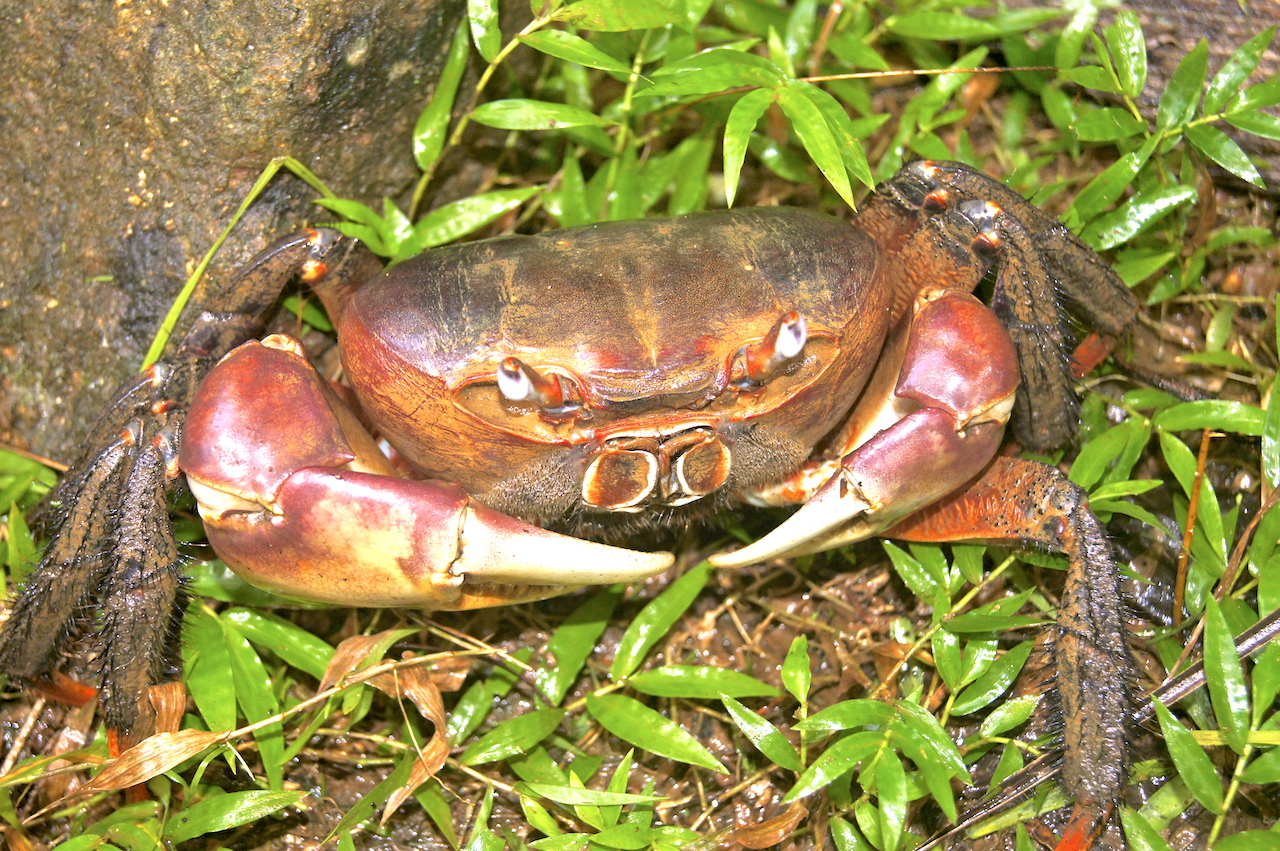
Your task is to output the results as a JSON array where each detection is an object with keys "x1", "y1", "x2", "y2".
[{"x1": 710, "y1": 289, "x2": 1018, "y2": 567}]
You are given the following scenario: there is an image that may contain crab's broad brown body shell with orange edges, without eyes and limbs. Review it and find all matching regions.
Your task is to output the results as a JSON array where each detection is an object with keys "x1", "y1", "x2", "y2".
[{"x1": 339, "y1": 209, "x2": 892, "y2": 522}]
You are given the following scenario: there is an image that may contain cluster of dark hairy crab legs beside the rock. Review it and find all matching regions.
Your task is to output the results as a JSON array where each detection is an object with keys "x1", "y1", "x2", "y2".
[{"x1": 0, "y1": 230, "x2": 365, "y2": 747}]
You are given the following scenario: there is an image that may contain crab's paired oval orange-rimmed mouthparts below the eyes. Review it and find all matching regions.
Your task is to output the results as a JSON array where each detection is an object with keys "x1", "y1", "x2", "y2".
[{"x1": 582, "y1": 426, "x2": 732, "y2": 512}]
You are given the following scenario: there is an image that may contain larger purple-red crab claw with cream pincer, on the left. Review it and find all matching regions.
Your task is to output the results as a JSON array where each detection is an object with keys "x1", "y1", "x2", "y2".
[{"x1": 180, "y1": 335, "x2": 673, "y2": 609}]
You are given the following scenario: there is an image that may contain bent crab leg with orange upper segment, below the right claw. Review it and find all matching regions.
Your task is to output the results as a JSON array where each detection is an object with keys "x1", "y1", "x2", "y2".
[{"x1": 884, "y1": 458, "x2": 1134, "y2": 839}]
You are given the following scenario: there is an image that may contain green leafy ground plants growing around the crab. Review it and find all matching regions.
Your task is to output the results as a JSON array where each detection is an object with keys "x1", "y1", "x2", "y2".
[{"x1": 0, "y1": 0, "x2": 1280, "y2": 851}]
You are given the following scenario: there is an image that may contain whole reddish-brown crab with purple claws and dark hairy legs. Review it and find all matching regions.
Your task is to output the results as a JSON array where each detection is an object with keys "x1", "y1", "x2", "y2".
[{"x1": 0, "y1": 161, "x2": 1135, "y2": 844}]
